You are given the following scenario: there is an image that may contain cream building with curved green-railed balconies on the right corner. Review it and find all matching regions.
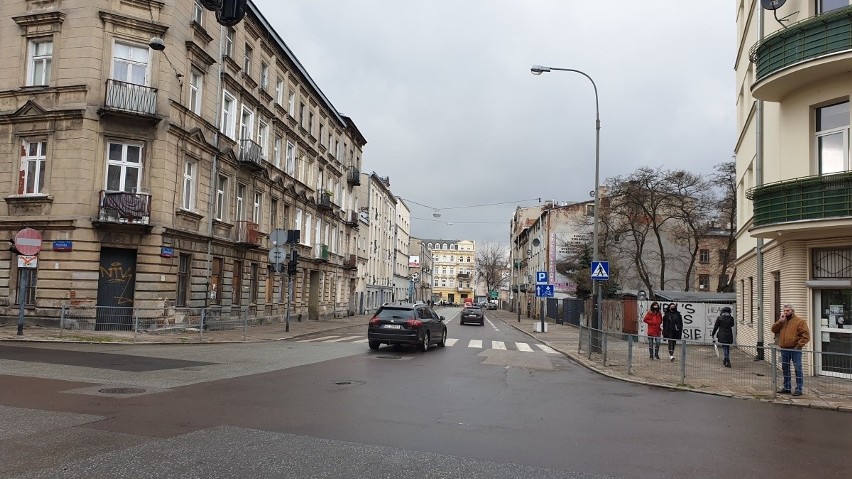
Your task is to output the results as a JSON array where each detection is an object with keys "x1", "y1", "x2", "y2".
[{"x1": 736, "y1": 0, "x2": 852, "y2": 378}]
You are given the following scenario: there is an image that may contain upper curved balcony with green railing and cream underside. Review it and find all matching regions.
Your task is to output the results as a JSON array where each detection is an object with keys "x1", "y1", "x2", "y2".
[{"x1": 750, "y1": 7, "x2": 852, "y2": 101}]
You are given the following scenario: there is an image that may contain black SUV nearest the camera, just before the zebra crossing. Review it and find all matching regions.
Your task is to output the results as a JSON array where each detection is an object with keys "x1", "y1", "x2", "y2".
[{"x1": 367, "y1": 303, "x2": 447, "y2": 351}]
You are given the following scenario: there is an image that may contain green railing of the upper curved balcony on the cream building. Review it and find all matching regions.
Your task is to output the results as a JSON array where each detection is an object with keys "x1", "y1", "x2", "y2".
[{"x1": 750, "y1": 7, "x2": 852, "y2": 81}]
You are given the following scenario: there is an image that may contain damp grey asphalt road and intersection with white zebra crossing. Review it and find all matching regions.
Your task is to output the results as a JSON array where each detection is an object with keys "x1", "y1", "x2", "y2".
[{"x1": 0, "y1": 309, "x2": 852, "y2": 478}]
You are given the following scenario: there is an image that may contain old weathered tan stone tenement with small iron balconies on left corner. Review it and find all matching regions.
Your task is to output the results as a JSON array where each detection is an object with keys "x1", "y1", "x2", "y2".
[{"x1": 0, "y1": 0, "x2": 366, "y2": 326}]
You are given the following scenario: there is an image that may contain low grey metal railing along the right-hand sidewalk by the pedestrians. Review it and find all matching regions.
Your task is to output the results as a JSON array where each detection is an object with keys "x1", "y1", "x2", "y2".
[{"x1": 577, "y1": 325, "x2": 852, "y2": 400}]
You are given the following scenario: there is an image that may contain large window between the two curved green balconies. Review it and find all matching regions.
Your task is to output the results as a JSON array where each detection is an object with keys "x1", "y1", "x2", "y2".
[{"x1": 816, "y1": 102, "x2": 849, "y2": 175}]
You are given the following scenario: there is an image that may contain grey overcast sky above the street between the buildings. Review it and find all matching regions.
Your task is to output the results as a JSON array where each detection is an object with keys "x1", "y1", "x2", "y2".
[{"x1": 254, "y1": 0, "x2": 736, "y2": 248}]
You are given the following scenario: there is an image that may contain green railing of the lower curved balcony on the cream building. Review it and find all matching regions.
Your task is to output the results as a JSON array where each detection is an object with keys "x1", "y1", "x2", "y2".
[{"x1": 746, "y1": 172, "x2": 852, "y2": 226}]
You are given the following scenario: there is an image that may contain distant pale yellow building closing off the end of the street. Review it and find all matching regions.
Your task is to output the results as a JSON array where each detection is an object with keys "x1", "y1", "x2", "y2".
[{"x1": 421, "y1": 239, "x2": 476, "y2": 304}]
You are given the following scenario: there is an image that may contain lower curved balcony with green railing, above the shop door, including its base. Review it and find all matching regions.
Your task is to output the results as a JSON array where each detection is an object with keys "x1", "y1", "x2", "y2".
[{"x1": 746, "y1": 172, "x2": 852, "y2": 237}]
